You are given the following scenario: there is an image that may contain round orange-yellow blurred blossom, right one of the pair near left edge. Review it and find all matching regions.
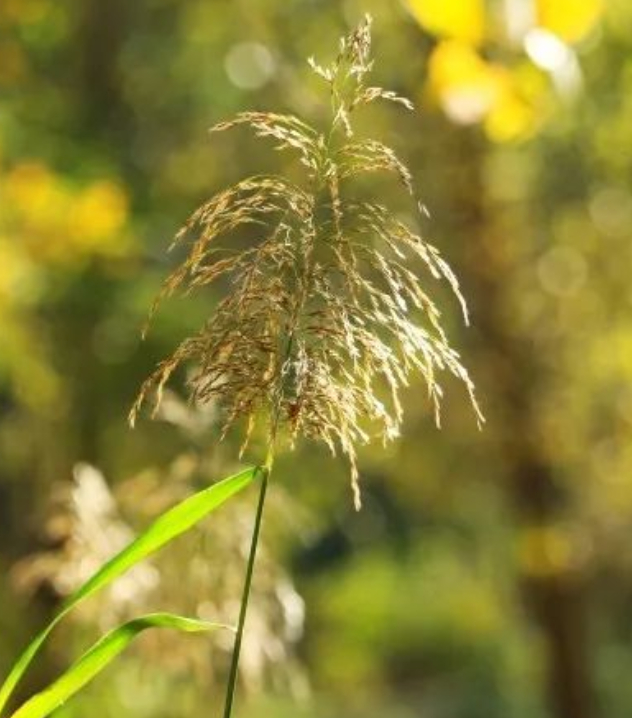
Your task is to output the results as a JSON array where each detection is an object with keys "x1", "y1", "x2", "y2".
[{"x1": 71, "y1": 181, "x2": 128, "y2": 245}]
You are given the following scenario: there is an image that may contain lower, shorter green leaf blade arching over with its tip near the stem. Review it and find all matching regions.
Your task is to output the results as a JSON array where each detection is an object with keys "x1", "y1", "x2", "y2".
[{"x1": 12, "y1": 613, "x2": 227, "y2": 718}]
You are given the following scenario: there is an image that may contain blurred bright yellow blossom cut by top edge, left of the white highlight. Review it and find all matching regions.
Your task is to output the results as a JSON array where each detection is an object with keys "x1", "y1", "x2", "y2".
[{"x1": 408, "y1": 0, "x2": 485, "y2": 45}]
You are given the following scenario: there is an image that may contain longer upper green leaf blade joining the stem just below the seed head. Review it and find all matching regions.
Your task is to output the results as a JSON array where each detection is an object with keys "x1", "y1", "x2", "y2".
[{"x1": 0, "y1": 467, "x2": 258, "y2": 715}]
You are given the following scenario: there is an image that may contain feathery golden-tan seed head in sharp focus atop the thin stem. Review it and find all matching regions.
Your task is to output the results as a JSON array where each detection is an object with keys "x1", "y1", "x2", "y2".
[{"x1": 130, "y1": 17, "x2": 483, "y2": 506}]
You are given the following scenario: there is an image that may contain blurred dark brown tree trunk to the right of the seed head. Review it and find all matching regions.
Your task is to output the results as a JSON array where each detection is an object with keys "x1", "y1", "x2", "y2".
[{"x1": 444, "y1": 132, "x2": 595, "y2": 718}]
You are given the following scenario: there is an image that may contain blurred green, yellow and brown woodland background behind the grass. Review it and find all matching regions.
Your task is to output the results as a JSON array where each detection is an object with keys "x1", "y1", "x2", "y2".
[{"x1": 0, "y1": 0, "x2": 632, "y2": 718}]
